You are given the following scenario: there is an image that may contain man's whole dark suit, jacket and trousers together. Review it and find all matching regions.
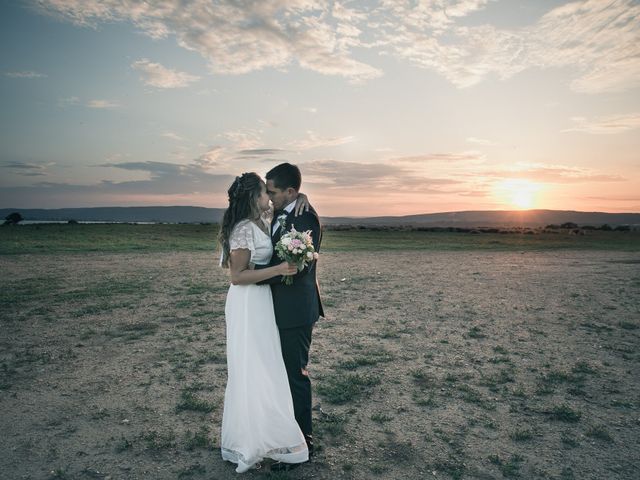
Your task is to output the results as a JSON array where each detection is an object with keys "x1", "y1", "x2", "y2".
[{"x1": 256, "y1": 207, "x2": 324, "y2": 435}]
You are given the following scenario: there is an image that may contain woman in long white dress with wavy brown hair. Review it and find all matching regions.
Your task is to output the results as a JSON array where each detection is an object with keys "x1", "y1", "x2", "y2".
[{"x1": 219, "y1": 173, "x2": 309, "y2": 473}]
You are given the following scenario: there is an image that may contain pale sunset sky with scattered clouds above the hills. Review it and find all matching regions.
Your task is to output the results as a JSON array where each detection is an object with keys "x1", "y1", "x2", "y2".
[{"x1": 0, "y1": 0, "x2": 640, "y2": 216}]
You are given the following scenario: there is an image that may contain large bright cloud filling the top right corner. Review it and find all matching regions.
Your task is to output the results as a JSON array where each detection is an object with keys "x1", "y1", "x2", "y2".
[{"x1": 376, "y1": 0, "x2": 640, "y2": 93}]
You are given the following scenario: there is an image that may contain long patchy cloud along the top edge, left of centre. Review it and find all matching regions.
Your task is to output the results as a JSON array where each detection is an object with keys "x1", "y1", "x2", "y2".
[{"x1": 36, "y1": 0, "x2": 382, "y2": 82}]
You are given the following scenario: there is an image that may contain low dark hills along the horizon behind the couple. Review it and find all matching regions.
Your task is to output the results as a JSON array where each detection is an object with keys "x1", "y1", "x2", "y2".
[{"x1": 0, "y1": 207, "x2": 640, "y2": 227}]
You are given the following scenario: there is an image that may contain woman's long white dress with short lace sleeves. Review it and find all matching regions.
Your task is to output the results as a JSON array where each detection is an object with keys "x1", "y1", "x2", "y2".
[{"x1": 221, "y1": 220, "x2": 309, "y2": 473}]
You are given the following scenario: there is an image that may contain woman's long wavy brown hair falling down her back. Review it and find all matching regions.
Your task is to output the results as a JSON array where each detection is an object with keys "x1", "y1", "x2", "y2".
[{"x1": 218, "y1": 172, "x2": 264, "y2": 268}]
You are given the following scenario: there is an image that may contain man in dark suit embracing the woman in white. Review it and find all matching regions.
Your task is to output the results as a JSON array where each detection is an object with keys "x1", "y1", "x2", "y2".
[{"x1": 256, "y1": 163, "x2": 324, "y2": 462}]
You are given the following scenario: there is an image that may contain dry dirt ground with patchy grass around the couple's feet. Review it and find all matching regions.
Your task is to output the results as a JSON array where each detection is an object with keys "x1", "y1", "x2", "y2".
[{"x1": 0, "y1": 251, "x2": 640, "y2": 479}]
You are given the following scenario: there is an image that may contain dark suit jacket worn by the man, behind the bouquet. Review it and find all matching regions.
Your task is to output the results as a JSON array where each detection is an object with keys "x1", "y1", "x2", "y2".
[{"x1": 256, "y1": 207, "x2": 324, "y2": 329}]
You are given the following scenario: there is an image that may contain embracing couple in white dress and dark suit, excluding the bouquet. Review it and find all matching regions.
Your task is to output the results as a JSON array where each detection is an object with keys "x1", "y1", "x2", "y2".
[{"x1": 219, "y1": 163, "x2": 324, "y2": 473}]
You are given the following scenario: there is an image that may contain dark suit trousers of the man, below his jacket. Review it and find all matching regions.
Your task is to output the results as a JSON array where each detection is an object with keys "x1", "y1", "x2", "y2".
[{"x1": 280, "y1": 325, "x2": 313, "y2": 435}]
